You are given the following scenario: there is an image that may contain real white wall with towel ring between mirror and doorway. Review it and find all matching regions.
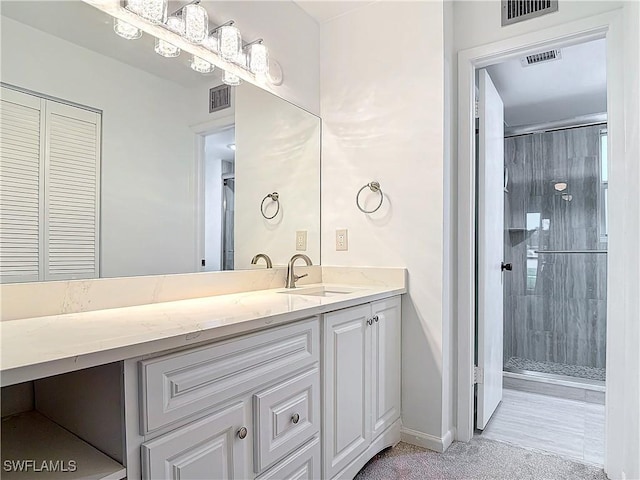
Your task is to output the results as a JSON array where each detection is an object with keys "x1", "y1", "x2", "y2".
[{"x1": 320, "y1": 1, "x2": 451, "y2": 448}]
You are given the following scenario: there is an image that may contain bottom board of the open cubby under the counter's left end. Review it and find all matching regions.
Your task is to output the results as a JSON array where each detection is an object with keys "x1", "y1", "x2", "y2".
[{"x1": 2, "y1": 410, "x2": 127, "y2": 480}]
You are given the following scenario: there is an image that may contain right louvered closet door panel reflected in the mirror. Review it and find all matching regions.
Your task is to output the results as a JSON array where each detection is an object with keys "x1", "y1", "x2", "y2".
[{"x1": 44, "y1": 101, "x2": 100, "y2": 280}]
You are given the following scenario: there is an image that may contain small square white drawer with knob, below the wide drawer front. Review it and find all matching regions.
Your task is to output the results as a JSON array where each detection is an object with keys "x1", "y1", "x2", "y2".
[{"x1": 253, "y1": 367, "x2": 320, "y2": 473}]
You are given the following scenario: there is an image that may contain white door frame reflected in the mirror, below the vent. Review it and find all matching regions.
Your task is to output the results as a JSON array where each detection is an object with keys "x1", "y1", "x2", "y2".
[{"x1": 191, "y1": 114, "x2": 236, "y2": 272}]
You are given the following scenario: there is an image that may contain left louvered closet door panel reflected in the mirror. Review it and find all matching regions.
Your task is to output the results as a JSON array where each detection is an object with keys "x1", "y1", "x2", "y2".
[{"x1": 0, "y1": 87, "x2": 45, "y2": 283}]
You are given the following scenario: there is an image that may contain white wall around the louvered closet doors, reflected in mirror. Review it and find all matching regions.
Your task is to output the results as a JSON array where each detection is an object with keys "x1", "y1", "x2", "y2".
[{"x1": 2, "y1": 17, "x2": 195, "y2": 277}]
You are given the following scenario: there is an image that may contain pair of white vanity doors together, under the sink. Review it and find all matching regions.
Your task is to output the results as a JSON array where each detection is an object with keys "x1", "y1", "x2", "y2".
[{"x1": 322, "y1": 296, "x2": 401, "y2": 479}]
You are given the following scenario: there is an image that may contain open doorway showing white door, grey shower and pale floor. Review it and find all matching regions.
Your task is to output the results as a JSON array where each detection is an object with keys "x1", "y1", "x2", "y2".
[{"x1": 474, "y1": 39, "x2": 608, "y2": 465}]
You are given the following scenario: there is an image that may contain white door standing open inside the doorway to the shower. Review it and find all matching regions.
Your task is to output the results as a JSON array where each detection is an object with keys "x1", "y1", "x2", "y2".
[{"x1": 476, "y1": 70, "x2": 504, "y2": 430}]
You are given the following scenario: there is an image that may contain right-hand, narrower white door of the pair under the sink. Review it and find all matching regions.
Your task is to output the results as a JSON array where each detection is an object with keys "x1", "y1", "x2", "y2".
[{"x1": 371, "y1": 297, "x2": 401, "y2": 440}]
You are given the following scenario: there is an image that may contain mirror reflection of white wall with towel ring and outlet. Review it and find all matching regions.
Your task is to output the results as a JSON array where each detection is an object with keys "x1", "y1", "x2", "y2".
[{"x1": 234, "y1": 83, "x2": 320, "y2": 268}]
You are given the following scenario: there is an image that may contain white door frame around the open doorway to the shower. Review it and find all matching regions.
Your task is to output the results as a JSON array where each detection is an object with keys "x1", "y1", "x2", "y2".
[{"x1": 456, "y1": 9, "x2": 633, "y2": 471}]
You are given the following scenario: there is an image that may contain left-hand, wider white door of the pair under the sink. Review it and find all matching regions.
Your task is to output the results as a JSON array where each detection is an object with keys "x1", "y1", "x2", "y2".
[{"x1": 322, "y1": 304, "x2": 371, "y2": 479}]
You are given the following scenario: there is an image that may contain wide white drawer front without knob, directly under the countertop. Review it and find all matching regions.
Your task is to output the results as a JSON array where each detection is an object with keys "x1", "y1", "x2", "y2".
[{"x1": 140, "y1": 318, "x2": 320, "y2": 435}]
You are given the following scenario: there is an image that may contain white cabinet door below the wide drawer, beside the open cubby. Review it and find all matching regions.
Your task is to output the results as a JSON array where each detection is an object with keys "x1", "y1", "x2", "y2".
[{"x1": 142, "y1": 401, "x2": 252, "y2": 480}]
